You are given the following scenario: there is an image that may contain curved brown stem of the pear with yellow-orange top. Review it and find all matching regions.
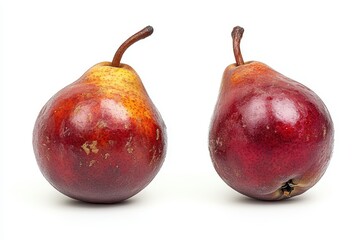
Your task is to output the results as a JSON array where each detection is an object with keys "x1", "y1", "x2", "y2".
[{"x1": 111, "y1": 26, "x2": 154, "y2": 67}]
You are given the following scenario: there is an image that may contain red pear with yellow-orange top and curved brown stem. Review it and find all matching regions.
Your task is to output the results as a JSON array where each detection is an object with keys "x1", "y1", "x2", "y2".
[{"x1": 33, "y1": 26, "x2": 167, "y2": 203}]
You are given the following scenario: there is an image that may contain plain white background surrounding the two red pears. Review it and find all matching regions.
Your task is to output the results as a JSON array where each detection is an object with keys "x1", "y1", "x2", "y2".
[{"x1": 0, "y1": 0, "x2": 360, "y2": 239}]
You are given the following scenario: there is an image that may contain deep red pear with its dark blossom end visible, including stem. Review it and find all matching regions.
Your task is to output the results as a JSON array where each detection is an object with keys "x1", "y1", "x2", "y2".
[{"x1": 209, "y1": 26, "x2": 334, "y2": 200}]
